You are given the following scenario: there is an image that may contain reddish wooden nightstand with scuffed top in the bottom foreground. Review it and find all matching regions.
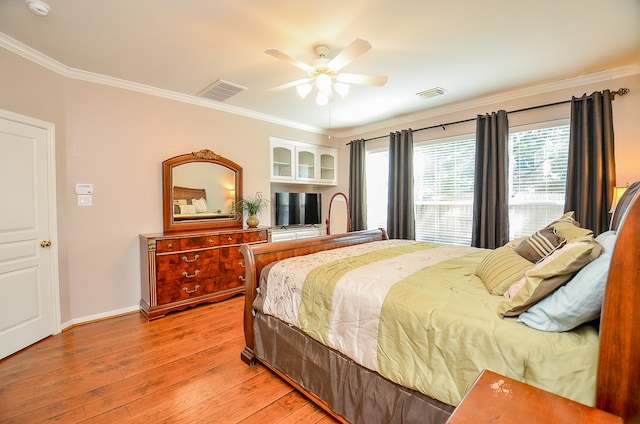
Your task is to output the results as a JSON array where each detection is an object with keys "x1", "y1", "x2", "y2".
[{"x1": 447, "y1": 370, "x2": 623, "y2": 424}]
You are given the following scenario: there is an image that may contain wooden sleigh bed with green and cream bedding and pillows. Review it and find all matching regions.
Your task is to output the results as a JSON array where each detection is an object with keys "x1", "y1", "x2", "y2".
[{"x1": 241, "y1": 183, "x2": 640, "y2": 423}]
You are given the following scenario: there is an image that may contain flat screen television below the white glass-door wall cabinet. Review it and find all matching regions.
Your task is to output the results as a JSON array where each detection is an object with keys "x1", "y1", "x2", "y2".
[{"x1": 275, "y1": 192, "x2": 322, "y2": 227}]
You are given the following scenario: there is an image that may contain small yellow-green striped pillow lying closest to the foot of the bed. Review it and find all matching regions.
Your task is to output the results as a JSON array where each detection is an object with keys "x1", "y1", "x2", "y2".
[{"x1": 475, "y1": 244, "x2": 533, "y2": 296}]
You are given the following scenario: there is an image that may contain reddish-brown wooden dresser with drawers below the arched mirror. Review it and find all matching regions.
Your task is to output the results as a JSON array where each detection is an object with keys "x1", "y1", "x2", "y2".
[{"x1": 140, "y1": 228, "x2": 271, "y2": 320}]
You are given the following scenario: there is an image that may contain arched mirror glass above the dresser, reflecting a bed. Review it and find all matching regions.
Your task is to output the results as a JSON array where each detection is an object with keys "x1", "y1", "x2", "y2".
[{"x1": 172, "y1": 162, "x2": 235, "y2": 221}]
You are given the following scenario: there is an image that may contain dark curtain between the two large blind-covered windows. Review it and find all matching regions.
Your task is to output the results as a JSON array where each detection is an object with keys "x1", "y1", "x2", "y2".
[{"x1": 471, "y1": 110, "x2": 509, "y2": 249}]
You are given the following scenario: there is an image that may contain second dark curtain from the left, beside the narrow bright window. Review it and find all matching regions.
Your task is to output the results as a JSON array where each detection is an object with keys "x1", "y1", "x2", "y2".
[{"x1": 387, "y1": 129, "x2": 415, "y2": 240}]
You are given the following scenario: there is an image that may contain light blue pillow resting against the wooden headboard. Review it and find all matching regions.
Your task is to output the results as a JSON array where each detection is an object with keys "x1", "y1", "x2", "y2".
[{"x1": 518, "y1": 231, "x2": 617, "y2": 331}]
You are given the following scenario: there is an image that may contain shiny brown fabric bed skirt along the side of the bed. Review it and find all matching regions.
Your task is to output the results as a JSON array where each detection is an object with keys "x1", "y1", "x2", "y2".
[{"x1": 253, "y1": 313, "x2": 454, "y2": 424}]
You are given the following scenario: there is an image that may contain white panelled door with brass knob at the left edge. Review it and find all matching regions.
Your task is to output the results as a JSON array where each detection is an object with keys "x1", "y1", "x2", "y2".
[{"x1": 0, "y1": 110, "x2": 60, "y2": 359}]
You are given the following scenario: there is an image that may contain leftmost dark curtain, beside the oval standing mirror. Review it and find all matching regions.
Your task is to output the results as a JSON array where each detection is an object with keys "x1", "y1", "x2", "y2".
[{"x1": 349, "y1": 140, "x2": 367, "y2": 231}]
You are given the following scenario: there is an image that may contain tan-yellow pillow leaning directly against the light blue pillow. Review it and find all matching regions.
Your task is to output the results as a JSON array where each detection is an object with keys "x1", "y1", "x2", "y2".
[{"x1": 498, "y1": 236, "x2": 602, "y2": 317}]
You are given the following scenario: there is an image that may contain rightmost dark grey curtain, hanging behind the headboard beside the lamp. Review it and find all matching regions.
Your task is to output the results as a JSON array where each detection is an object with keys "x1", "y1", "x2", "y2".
[{"x1": 564, "y1": 90, "x2": 616, "y2": 235}]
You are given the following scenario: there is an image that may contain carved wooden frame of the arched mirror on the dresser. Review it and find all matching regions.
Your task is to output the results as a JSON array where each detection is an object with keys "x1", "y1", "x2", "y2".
[{"x1": 162, "y1": 149, "x2": 242, "y2": 233}]
